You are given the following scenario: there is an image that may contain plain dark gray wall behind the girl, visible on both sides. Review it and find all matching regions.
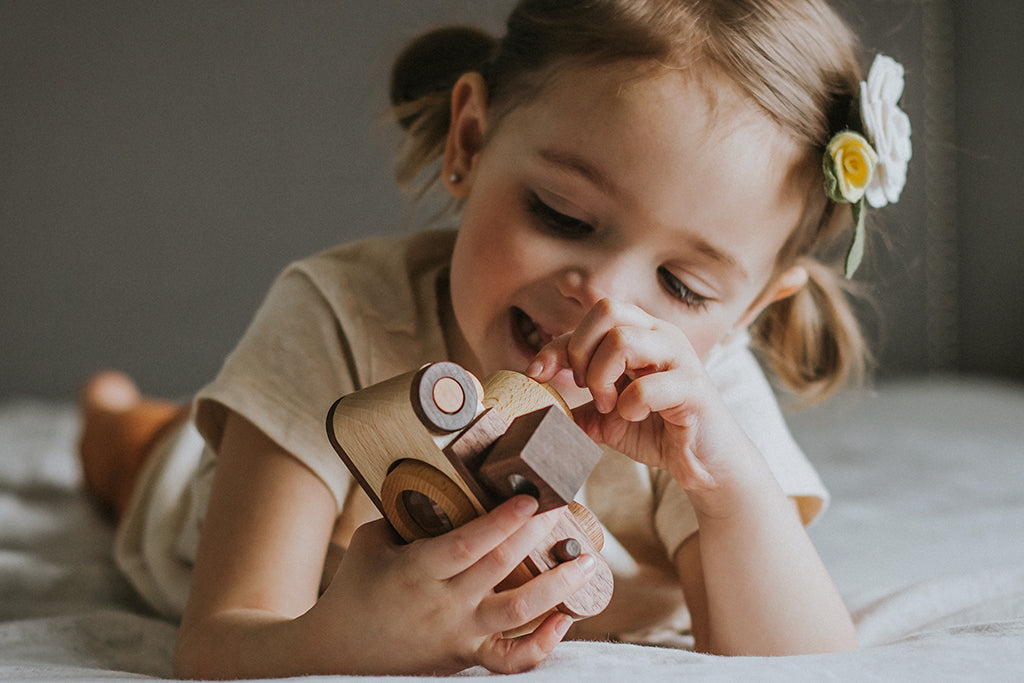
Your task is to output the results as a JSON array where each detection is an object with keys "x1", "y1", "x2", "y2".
[{"x1": 0, "y1": 0, "x2": 1024, "y2": 398}]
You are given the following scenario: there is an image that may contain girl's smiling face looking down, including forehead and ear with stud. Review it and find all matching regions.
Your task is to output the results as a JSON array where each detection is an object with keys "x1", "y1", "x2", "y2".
[{"x1": 444, "y1": 62, "x2": 806, "y2": 404}]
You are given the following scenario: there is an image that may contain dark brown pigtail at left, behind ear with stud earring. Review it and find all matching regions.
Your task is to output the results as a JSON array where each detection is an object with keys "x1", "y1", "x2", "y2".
[{"x1": 390, "y1": 27, "x2": 498, "y2": 199}]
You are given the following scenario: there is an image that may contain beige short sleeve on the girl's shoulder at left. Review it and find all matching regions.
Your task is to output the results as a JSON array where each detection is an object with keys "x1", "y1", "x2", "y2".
[{"x1": 196, "y1": 266, "x2": 356, "y2": 507}]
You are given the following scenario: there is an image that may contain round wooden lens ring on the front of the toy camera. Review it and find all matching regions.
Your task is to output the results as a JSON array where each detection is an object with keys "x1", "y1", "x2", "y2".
[{"x1": 381, "y1": 460, "x2": 477, "y2": 543}]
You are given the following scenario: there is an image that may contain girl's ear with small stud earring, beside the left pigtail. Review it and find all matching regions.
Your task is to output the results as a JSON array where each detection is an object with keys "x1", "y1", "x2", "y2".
[{"x1": 441, "y1": 73, "x2": 487, "y2": 200}]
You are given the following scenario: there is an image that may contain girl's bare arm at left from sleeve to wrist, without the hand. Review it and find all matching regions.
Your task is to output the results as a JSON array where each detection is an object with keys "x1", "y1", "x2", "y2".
[{"x1": 174, "y1": 414, "x2": 337, "y2": 678}]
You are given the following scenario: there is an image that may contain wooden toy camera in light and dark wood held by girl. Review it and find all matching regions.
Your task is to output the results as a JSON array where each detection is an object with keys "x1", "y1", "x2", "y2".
[{"x1": 327, "y1": 361, "x2": 612, "y2": 630}]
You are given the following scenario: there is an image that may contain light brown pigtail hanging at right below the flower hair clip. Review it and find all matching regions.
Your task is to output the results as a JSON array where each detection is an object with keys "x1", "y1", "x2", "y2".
[{"x1": 751, "y1": 258, "x2": 868, "y2": 404}]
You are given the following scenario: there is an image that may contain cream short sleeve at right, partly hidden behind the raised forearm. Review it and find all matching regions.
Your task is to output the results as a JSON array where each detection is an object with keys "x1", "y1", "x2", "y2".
[{"x1": 652, "y1": 334, "x2": 828, "y2": 557}]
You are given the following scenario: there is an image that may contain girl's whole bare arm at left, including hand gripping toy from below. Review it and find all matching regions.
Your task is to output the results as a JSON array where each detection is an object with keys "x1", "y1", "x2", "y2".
[{"x1": 175, "y1": 414, "x2": 593, "y2": 678}]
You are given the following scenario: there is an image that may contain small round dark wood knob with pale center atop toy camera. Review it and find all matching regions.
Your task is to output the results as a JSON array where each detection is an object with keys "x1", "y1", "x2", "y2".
[{"x1": 410, "y1": 360, "x2": 478, "y2": 434}]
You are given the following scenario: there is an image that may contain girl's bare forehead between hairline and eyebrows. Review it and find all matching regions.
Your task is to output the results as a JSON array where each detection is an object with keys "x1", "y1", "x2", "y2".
[{"x1": 503, "y1": 66, "x2": 807, "y2": 266}]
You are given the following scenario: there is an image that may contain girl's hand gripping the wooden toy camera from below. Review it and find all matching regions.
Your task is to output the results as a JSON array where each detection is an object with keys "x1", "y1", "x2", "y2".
[{"x1": 315, "y1": 496, "x2": 594, "y2": 674}]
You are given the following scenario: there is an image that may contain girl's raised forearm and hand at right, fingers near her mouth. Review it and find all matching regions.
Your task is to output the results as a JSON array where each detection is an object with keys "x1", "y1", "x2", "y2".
[{"x1": 531, "y1": 300, "x2": 857, "y2": 654}]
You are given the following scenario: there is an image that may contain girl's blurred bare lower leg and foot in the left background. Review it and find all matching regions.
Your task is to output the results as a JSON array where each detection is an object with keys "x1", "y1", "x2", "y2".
[{"x1": 79, "y1": 371, "x2": 188, "y2": 520}]
